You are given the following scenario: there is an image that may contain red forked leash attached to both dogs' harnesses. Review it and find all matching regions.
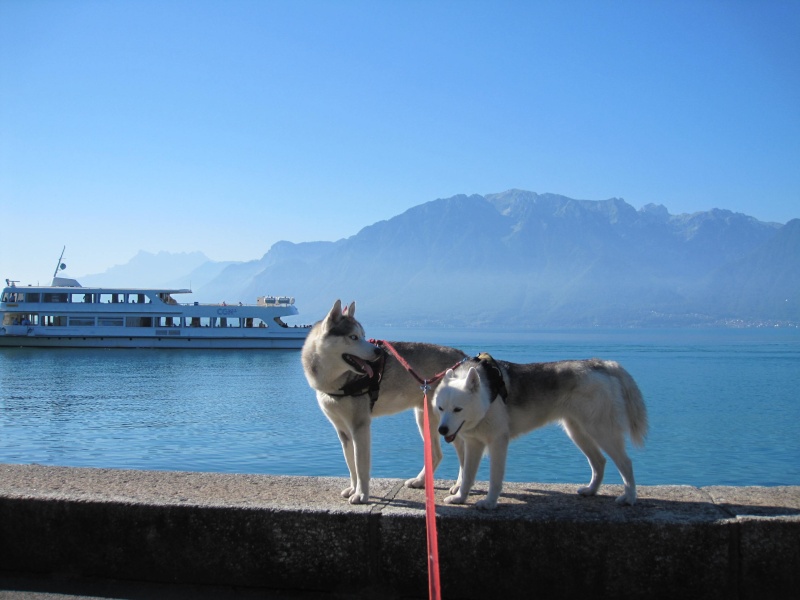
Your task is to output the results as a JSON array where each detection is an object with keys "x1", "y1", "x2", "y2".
[{"x1": 369, "y1": 340, "x2": 456, "y2": 600}]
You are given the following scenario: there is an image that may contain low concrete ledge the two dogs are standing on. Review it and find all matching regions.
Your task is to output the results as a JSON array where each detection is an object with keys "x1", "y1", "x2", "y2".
[{"x1": 0, "y1": 465, "x2": 800, "y2": 600}]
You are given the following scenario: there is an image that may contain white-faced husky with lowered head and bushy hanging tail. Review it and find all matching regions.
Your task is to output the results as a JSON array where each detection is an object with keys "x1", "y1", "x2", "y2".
[{"x1": 433, "y1": 354, "x2": 647, "y2": 509}]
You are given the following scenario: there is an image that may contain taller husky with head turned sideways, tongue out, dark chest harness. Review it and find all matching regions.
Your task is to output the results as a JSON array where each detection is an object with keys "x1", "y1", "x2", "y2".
[{"x1": 301, "y1": 300, "x2": 467, "y2": 504}]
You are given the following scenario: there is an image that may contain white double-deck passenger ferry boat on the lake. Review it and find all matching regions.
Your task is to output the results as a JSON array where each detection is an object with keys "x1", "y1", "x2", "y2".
[{"x1": 0, "y1": 254, "x2": 310, "y2": 349}]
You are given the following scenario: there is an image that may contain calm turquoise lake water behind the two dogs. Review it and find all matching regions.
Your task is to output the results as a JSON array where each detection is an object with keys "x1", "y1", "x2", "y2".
[{"x1": 0, "y1": 329, "x2": 800, "y2": 485}]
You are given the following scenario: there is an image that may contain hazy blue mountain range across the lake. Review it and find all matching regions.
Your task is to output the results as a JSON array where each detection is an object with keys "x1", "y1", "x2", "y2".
[{"x1": 81, "y1": 190, "x2": 800, "y2": 328}]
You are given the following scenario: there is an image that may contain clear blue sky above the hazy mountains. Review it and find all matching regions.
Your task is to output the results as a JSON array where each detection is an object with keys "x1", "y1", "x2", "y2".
[{"x1": 0, "y1": 0, "x2": 800, "y2": 283}]
